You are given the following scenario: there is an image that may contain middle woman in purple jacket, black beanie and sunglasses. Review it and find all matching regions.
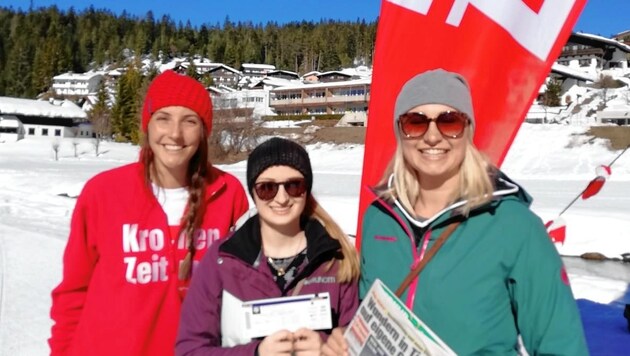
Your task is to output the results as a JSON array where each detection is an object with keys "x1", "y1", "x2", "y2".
[{"x1": 176, "y1": 138, "x2": 359, "y2": 356}]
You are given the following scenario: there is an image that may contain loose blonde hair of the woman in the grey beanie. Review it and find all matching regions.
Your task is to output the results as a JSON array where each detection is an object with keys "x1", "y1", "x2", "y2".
[{"x1": 379, "y1": 130, "x2": 496, "y2": 216}]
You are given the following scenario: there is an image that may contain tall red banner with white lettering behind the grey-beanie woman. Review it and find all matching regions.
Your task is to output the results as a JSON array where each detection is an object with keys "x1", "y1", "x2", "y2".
[{"x1": 357, "y1": 0, "x2": 586, "y2": 246}]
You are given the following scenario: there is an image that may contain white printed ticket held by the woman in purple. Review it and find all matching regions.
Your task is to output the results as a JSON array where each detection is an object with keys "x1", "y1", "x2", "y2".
[{"x1": 242, "y1": 292, "x2": 332, "y2": 338}]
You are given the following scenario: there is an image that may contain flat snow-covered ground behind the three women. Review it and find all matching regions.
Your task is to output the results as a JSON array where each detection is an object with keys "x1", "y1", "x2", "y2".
[{"x1": 0, "y1": 124, "x2": 630, "y2": 355}]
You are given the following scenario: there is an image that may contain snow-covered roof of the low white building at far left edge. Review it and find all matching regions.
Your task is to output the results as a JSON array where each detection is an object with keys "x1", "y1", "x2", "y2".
[{"x1": 0, "y1": 96, "x2": 87, "y2": 119}]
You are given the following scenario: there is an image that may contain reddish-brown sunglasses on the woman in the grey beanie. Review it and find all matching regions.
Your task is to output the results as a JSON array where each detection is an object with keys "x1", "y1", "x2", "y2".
[{"x1": 398, "y1": 111, "x2": 470, "y2": 138}]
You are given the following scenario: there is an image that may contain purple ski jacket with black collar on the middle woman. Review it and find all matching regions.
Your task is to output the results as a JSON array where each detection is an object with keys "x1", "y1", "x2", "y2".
[{"x1": 175, "y1": 215, "x2": 359, "y2": 355}]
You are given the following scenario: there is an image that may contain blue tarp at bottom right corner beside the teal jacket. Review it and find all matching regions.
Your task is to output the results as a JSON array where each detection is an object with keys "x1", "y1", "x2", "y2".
[{"x1": 577, "y1": 299, "x2": 630, "y2": 355}]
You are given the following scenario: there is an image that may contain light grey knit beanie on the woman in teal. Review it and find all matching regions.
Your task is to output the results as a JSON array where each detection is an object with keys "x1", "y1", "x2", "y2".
[{"x1": 394, "y1": 69, "x2": 475, "y2": 135}]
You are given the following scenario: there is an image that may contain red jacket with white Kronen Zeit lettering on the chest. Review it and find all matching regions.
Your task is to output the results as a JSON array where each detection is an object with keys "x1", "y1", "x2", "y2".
[{"x1": 49, "y1": 163, "x2": 249, "y2": 355}]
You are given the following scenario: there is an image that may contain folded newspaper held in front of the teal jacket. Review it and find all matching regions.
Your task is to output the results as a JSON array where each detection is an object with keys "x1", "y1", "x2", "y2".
[{"x1": 345, "y1": 279, "x2": 455, "y2": 356}]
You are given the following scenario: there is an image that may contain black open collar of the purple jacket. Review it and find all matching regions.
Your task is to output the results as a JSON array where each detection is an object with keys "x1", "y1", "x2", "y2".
[{"x1": 219, "y1": 214, "x2": 341, "y2": 266}]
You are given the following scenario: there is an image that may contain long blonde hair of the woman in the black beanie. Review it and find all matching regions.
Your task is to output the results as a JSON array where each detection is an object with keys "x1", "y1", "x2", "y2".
[{"x1": 303, "y1": 194, "x2": 359, "y2": 283}]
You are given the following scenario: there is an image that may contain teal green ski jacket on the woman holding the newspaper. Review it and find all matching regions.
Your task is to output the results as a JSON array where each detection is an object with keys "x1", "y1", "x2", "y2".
[{"x1": 359, "y1": 174, "x2": 588, "y2": 356}]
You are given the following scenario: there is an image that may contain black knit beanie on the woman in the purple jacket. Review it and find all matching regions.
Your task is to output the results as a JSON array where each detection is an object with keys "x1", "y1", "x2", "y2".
[{"x1": 247, "y1": 137, "x2": 313, "y2": 194}]
